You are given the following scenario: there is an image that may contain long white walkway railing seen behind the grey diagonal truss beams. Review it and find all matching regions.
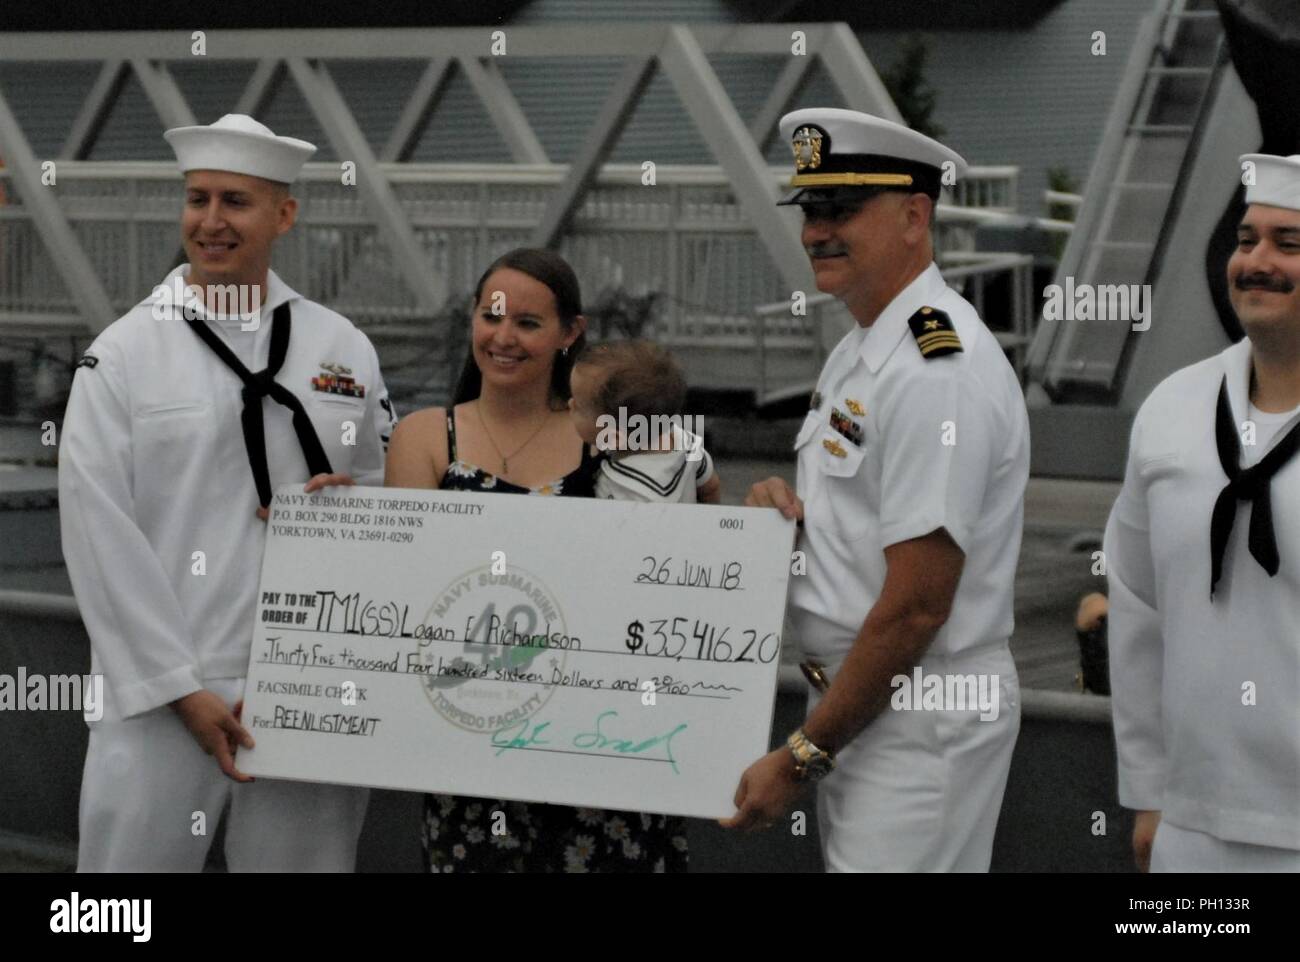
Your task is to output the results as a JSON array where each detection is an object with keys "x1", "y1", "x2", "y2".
[{"x1": 0, "y1": 161, "x2": 1017, "y2": 346}]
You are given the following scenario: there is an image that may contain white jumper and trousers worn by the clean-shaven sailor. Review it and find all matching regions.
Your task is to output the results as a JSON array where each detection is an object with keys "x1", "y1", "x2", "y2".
[{"x1": 59, "y1": 267, "x2": 393, "y2": 871}]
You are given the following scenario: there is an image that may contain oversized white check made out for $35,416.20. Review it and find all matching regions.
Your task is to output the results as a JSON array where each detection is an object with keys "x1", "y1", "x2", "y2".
[{"x1": 237, "y1": 485, "x2": 794, "y2": 818}]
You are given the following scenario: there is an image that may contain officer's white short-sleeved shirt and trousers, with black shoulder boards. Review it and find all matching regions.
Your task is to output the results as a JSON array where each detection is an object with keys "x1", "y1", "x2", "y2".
[{"x1": 790, "y1": 264, "x2": 1030, "y2": 871}]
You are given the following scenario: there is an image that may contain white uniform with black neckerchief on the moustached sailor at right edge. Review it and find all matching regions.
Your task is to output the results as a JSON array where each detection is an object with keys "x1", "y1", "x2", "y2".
[{"x1": 1105, "y1": 339, "x2": 1300, "y2": 871}]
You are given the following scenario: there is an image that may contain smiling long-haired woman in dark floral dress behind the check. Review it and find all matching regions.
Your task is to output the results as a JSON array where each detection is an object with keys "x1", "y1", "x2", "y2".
[{"x1": 385, "y1": 248, "x2": 688, "y2": 872}]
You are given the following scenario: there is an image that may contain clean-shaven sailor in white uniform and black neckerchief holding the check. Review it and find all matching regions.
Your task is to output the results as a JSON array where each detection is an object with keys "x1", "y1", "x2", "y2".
[{"x1": 59, "y1": 114, "x2": 393, "y2": 871}]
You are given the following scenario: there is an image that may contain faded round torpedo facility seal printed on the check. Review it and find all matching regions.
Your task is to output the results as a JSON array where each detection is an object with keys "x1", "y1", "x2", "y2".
[{"x1": 420, "y1": 564, "x2": 581, "y2": 735}]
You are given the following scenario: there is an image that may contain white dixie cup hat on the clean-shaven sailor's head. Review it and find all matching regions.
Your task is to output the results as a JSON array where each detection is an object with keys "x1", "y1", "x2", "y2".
[{"x1": 163, "y1": 113, "x2": 316, "y2": 183}]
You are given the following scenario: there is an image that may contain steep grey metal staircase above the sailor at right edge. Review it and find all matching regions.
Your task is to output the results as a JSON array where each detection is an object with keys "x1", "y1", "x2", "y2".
[{"x1": 1028, "y1": 0, "x2": 1226, "y2": 403}]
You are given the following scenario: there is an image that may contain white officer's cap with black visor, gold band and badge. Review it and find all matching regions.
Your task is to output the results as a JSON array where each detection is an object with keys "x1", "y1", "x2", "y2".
[{"x1": 779, "y1": 107, "x2": 967, "y2": 204}]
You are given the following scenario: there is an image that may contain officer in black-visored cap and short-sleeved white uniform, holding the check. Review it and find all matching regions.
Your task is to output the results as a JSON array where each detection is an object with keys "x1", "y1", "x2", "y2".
[{"x1": 725, "y1": 109, "x2": 1028, "y2": 871}]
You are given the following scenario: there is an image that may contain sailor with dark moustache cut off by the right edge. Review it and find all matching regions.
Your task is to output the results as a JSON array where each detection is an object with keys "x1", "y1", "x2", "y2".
[{"x1": 1105, "y1": 153, "x2": 1300, "y2": 872}]
